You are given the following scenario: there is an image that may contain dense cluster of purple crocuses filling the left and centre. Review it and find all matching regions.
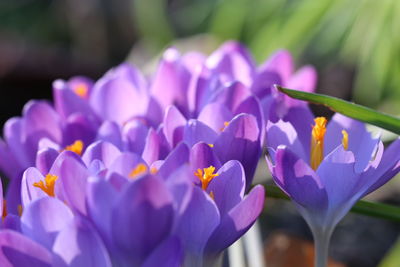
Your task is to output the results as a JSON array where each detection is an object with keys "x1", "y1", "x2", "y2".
[{"x1": 0, "y1": 42, "x2": 316, "y2": 267}]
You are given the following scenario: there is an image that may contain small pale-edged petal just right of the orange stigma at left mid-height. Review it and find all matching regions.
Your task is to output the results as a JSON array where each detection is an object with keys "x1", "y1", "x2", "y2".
[{"x1": 82, "y1": 141, "x2": 121, "y2": 167}]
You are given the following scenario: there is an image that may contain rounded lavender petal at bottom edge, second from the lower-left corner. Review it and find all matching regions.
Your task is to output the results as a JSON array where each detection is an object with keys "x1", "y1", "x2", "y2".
[{"x1": 53, "y1": 219, "x2": 111, "y2": 267}]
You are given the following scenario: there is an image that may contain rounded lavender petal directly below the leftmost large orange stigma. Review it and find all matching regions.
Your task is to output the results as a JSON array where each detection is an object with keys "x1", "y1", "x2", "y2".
[{"x1": 21, "y1": 197, "x2": 73, "y2": 250}]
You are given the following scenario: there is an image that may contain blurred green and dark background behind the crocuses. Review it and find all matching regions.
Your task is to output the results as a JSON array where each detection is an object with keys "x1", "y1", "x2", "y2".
[{"x1": 0, "y1": 0, "x2": 400, "y2": 267}]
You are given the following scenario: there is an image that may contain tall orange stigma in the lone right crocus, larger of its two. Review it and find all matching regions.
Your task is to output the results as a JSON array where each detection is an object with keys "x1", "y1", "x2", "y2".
[{"x1": 310, "y1": 117, "x2": 327, "y2": 170}]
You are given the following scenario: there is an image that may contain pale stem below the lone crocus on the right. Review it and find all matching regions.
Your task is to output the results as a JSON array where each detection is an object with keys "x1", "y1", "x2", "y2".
[{"x1": 312, "y1": 229, "x2": 332, "y2": 267}]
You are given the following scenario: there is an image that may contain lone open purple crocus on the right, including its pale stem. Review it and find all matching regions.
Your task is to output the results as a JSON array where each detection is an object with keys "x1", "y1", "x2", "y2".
[{"x1": 266, "y1": 114, "x2": 400, "y2": 266}]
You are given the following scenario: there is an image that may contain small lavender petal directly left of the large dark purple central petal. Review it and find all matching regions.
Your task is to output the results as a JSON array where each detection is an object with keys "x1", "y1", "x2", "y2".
[{"x1": 183, "y1": 119, "x2": 217, "y2": 147}]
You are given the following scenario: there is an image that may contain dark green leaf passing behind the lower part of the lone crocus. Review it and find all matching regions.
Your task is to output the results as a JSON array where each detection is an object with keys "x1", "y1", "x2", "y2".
[{"x1": 265, "y1": 185, "x2": 400, "y2": 222}]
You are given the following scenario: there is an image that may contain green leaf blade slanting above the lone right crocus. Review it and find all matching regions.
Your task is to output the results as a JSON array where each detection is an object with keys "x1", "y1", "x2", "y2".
[{"x1": 276, "y1": 86, "x2": 400, "y2": 134}]
